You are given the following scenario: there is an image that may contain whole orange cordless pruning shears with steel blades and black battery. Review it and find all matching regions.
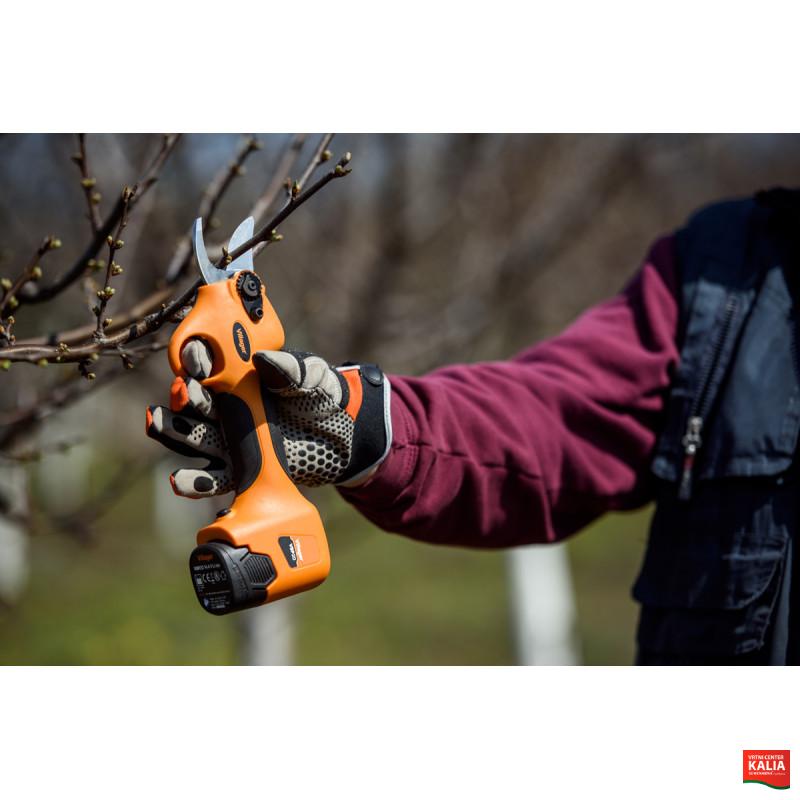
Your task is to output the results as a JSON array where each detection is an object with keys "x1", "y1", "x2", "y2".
[{"x1": 168, "y1": 217, "x2": 330, "y2": 614}]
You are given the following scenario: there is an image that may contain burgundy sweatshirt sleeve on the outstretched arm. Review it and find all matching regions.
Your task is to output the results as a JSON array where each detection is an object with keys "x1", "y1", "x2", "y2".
[{"x1": 341, "y1": 238, "x2": 678, "y2": 547}]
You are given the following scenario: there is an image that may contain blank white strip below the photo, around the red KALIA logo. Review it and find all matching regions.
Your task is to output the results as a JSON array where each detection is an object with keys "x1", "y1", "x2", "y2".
[{"x1": 0, "y1": 667, "x2": 798, "y2": 800}]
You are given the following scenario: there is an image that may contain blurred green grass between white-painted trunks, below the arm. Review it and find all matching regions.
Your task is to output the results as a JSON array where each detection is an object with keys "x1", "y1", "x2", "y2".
[{"x1": 0, "y1": 466, "x2": 649, "y2": 665}]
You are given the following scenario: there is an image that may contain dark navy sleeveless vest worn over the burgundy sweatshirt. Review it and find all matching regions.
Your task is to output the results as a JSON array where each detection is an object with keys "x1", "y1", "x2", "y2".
[{"x1": 633, "y1": 192, "x2": 800, "y2": 664}]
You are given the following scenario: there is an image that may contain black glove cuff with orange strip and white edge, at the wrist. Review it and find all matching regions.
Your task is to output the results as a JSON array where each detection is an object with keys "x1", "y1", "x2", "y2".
[{"x1": 335, "y1": 363, "x2": 392, "y2": 487}]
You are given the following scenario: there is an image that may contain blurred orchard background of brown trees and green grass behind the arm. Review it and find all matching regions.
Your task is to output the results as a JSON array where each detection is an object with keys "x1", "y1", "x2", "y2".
[{"x1": 0, "y1": 134, "x2": 800, "y2": 664}]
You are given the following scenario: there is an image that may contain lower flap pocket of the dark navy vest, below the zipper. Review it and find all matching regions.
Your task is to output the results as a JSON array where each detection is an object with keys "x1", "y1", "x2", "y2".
[{"x1": 633, "y1": 478, "x2": 798, "y2": 656}]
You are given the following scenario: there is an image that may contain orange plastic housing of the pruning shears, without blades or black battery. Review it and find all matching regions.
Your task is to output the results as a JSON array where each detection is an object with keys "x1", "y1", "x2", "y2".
[{"x1": 168, "y1": 276, "x2": 330, "y2": 602}]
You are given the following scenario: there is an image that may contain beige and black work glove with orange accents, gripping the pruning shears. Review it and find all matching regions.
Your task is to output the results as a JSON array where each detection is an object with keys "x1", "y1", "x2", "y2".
[{"x1": 147, "y1": 340, "x2": 392, "y2": 497}]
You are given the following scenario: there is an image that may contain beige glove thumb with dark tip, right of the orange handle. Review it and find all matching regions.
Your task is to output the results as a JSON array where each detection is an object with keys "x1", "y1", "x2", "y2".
[{"x1": 253, "y1": 350, "x2": 344, "y2": 405}]
